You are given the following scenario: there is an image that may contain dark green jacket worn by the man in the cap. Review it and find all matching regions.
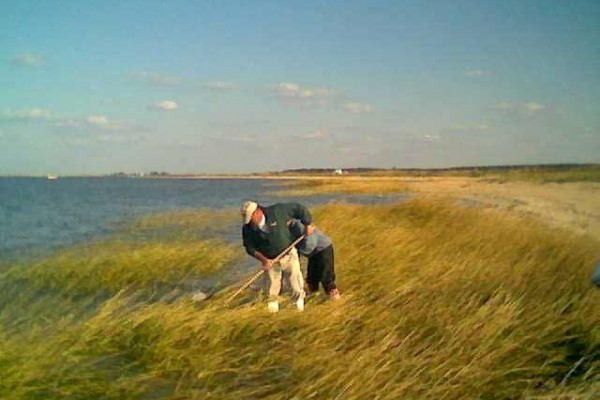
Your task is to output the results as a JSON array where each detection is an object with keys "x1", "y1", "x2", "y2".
[{"x1": 242, "y1": 203, "x2": 312, "y2": 259}]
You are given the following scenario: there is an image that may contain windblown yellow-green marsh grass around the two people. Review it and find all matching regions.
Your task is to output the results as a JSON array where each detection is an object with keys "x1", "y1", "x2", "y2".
[{"x1": 0, "y1": 200, "x2": 600, "y2": 400}]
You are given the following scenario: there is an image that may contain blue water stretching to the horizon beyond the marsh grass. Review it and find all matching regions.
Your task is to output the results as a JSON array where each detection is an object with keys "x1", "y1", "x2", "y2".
[{"x1": 0, "y1": 178, "x2": 398, "y2": 260}]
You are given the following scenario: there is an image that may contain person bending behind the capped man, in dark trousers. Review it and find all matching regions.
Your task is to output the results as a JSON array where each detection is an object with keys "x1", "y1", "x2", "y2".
[{"x1": 288, "y1": 219, "x2": 341, "y2": 300}]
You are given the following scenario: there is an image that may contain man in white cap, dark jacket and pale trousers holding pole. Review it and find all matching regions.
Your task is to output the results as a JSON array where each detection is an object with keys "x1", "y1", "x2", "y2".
[{"x1": 241, "y1": 200, "x2": 314, "y2": 312}]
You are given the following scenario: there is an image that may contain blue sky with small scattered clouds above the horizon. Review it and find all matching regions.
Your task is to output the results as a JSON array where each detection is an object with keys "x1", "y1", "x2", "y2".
[{"x1": 0, "y1": 0, "x2": 600, "y2": 175}]
